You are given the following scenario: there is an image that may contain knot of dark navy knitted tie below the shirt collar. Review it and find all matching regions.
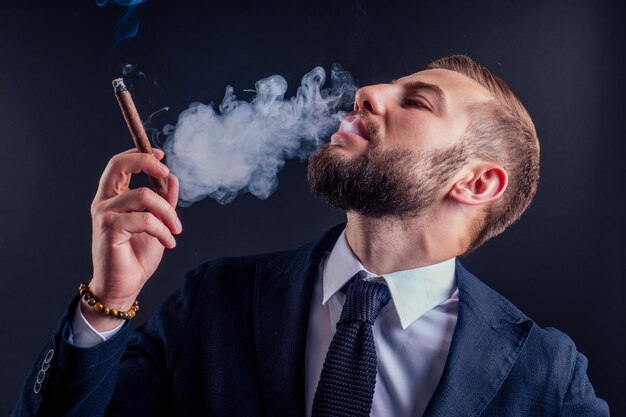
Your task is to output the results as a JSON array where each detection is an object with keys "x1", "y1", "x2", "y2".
[{"x1": 339, "y1": 277, "x2": 390, "y2": 324}]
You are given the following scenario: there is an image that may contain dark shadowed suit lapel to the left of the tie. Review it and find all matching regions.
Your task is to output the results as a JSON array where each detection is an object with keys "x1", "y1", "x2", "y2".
[{"x1": 254, "y1": 225, "x2": 345, "y2": 416}]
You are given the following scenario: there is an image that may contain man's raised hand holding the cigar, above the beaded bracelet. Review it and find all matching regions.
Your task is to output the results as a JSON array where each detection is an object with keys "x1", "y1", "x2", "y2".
[{"x1": 81, "y1": 149, "x2": 182, "y2": 331}]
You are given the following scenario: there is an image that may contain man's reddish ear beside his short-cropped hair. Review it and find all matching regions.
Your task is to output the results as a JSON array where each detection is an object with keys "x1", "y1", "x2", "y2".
[{"x1": 448, "y1": 161, "x2": 509, "y2": 206}]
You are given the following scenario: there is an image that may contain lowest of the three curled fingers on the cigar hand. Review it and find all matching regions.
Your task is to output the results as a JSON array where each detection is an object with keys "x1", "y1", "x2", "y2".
[{"x1": 100, "y1": 211, "x2": 176, "y2": 249}]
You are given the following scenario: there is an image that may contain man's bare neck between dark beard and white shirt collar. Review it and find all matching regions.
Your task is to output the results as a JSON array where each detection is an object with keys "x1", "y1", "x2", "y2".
[{"x1": 346, "y1": 212, "x2": 463, "y2": 275}]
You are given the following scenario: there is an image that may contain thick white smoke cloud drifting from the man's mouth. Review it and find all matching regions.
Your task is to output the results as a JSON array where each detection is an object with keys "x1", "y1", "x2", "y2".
[{"x1": 164, "y1": 64, "x2": 357, "y2": 206}]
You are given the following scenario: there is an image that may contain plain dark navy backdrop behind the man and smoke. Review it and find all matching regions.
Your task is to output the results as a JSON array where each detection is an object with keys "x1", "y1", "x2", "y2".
[{"x1": 0, "y1": 0, "x2": 626, "y2": 416}]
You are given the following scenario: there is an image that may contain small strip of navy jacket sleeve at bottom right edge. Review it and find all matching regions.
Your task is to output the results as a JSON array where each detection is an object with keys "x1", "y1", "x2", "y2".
[{"x1": 559, "y1": 353, "x2": 609, "y2": 417}]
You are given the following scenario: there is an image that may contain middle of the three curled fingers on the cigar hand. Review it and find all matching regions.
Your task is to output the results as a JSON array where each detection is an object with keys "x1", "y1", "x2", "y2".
[{"x1": 94, "y1": 187, "x2": 182, "y2": 234}]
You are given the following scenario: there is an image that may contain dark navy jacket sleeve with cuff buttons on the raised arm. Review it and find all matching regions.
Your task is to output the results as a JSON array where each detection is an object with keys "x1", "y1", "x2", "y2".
[{"x1": 11, "y1": 268, "x2": 201, "y2": 417}]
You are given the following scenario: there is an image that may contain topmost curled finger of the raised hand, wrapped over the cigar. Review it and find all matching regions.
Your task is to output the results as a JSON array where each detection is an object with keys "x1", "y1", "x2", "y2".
[{"x1": 94, "y1": 149, "x2": 170, "y2": 203}]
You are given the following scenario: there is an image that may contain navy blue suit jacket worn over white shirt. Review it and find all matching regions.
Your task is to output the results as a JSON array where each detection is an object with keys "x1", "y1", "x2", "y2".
[{"x1": 13, "y1": 226, "x2": 608, "y2": 417}]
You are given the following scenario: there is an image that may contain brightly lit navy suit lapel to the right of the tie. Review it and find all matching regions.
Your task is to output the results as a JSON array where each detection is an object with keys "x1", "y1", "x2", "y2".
[{"x1": 424, "y1": 262, "x2": 532, "y2": 417}]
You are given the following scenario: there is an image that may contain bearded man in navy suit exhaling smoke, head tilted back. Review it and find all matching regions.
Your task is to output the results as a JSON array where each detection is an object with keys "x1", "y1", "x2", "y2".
[{"x1": 14, "y1": 56, "x2": 608, "y2": 416}]
